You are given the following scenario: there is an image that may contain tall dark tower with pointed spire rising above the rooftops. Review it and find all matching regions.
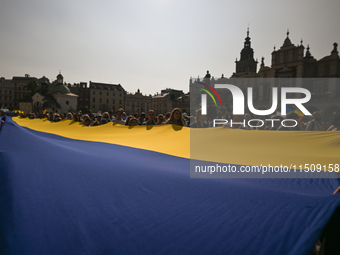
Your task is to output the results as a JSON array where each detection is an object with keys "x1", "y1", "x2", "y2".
[{"x1": 235, "y1": 28, "x2": 257, "y2": 75}]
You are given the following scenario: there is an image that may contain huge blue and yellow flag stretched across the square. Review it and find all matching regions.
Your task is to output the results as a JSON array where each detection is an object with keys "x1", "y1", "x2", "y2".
[{"x1": 0, "y1": 117, "x2": 340, "y2": 255}]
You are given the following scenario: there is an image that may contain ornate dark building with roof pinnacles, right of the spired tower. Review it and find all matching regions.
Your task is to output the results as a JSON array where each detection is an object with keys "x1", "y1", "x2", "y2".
[{"x1": 242, "y1": 31, "x2": 340, "y2": 121}]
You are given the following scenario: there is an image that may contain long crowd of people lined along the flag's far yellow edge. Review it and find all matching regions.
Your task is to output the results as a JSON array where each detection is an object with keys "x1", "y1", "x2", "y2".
[{"x1": 0, "y1": 108, "x2": 340, "y2": 131}]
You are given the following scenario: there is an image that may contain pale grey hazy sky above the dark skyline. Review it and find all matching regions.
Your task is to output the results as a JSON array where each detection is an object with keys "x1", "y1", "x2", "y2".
[{"x1": 0, "y1": 0, "x2": 340, "y2": 95}]
